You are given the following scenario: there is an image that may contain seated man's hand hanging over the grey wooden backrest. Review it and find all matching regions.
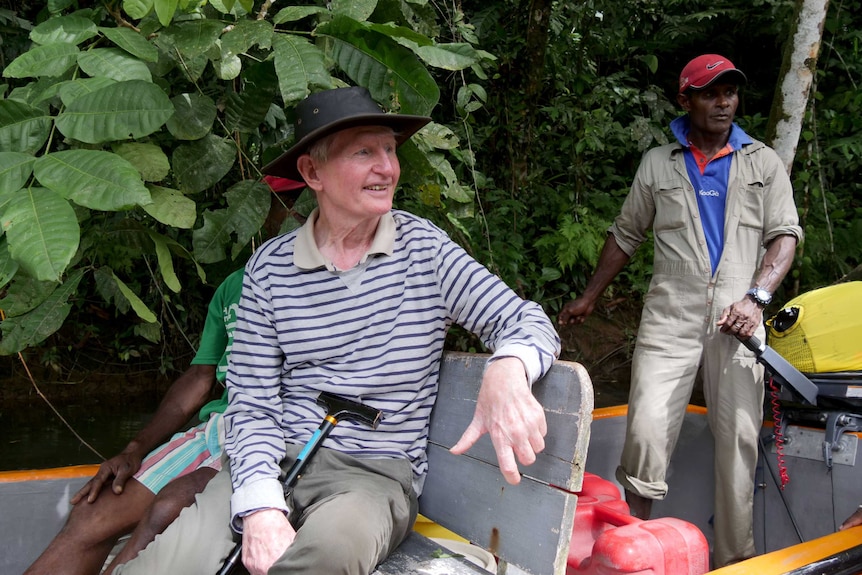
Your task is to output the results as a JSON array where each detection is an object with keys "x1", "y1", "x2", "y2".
[{"x1": 449, "y1": 357, "x2": 548, "y2": 485}]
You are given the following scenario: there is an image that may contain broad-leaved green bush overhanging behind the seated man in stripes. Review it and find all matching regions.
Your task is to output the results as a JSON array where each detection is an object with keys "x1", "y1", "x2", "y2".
[{"x1": 0, "y1": 0, "x2": 491, "y2": 366}]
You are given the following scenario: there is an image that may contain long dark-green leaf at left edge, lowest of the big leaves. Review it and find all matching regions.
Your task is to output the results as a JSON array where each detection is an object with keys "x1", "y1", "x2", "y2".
[{"x1": 0, "y1": 269, "x2": 84, "y2": 355}]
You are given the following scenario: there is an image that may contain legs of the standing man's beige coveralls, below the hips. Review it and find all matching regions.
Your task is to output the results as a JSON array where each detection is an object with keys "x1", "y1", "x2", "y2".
[{"x1": 616, "y1": 319, "x2": 764, "y2": 567}]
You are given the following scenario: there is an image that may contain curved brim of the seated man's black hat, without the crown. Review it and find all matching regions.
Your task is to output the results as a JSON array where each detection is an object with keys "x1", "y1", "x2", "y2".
[{"x1": 263, "y1": 113, "x2": 431, "y2": 182}]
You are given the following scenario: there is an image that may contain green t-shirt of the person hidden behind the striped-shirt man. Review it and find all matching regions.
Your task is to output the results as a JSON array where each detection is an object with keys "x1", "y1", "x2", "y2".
[{"x1": 192, "y1": 269, "x2": 244, "y2": 421}]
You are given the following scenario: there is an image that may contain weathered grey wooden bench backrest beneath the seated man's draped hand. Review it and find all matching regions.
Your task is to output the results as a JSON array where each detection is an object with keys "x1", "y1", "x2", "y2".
[{"x1": 412, "y1": 353, "x2": 593, "y2": 575}]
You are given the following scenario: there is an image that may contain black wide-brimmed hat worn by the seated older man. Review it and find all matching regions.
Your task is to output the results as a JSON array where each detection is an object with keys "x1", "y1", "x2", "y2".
[{"x1": 263, "y1": 86, "x2": 431, "y2": 181}]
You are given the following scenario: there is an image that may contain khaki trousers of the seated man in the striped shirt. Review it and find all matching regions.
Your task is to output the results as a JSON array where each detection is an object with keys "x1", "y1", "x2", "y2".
[{"x1": 116, "y1": 445, "x2": 418, "y2": 575}]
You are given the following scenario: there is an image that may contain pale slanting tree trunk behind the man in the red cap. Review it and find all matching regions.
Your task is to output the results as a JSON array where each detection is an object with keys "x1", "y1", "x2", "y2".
[{"x1": 766, "y1": 0, "x2": 829, "y2": 174}]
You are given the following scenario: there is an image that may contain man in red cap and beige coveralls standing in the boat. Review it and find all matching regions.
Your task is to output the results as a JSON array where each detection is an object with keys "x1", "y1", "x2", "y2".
[{"x1": 559, "y1": 54, "x2": 802, "y2": 567}]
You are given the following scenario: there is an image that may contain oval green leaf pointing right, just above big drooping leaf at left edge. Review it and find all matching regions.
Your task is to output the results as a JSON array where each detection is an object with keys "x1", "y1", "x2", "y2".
[{"x1": 33, "y1": 150, "x2": 152, "y2": 211}]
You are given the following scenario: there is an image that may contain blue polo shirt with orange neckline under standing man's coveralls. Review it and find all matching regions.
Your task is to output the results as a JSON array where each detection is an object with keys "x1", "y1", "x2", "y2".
[{"x1": 670, "y1": 115, "x2": 752, "y2": 274}]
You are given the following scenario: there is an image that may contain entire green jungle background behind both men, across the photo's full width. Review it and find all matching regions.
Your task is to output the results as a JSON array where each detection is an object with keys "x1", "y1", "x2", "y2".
[{"x1": 0, "y1": 0, "x2": 862, "y2": 374}]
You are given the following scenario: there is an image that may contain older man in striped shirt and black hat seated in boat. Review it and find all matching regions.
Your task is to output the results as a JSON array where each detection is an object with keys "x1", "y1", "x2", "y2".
[{"x1": 118, "y1": 87, "x2": 560, "y2": 575}]
